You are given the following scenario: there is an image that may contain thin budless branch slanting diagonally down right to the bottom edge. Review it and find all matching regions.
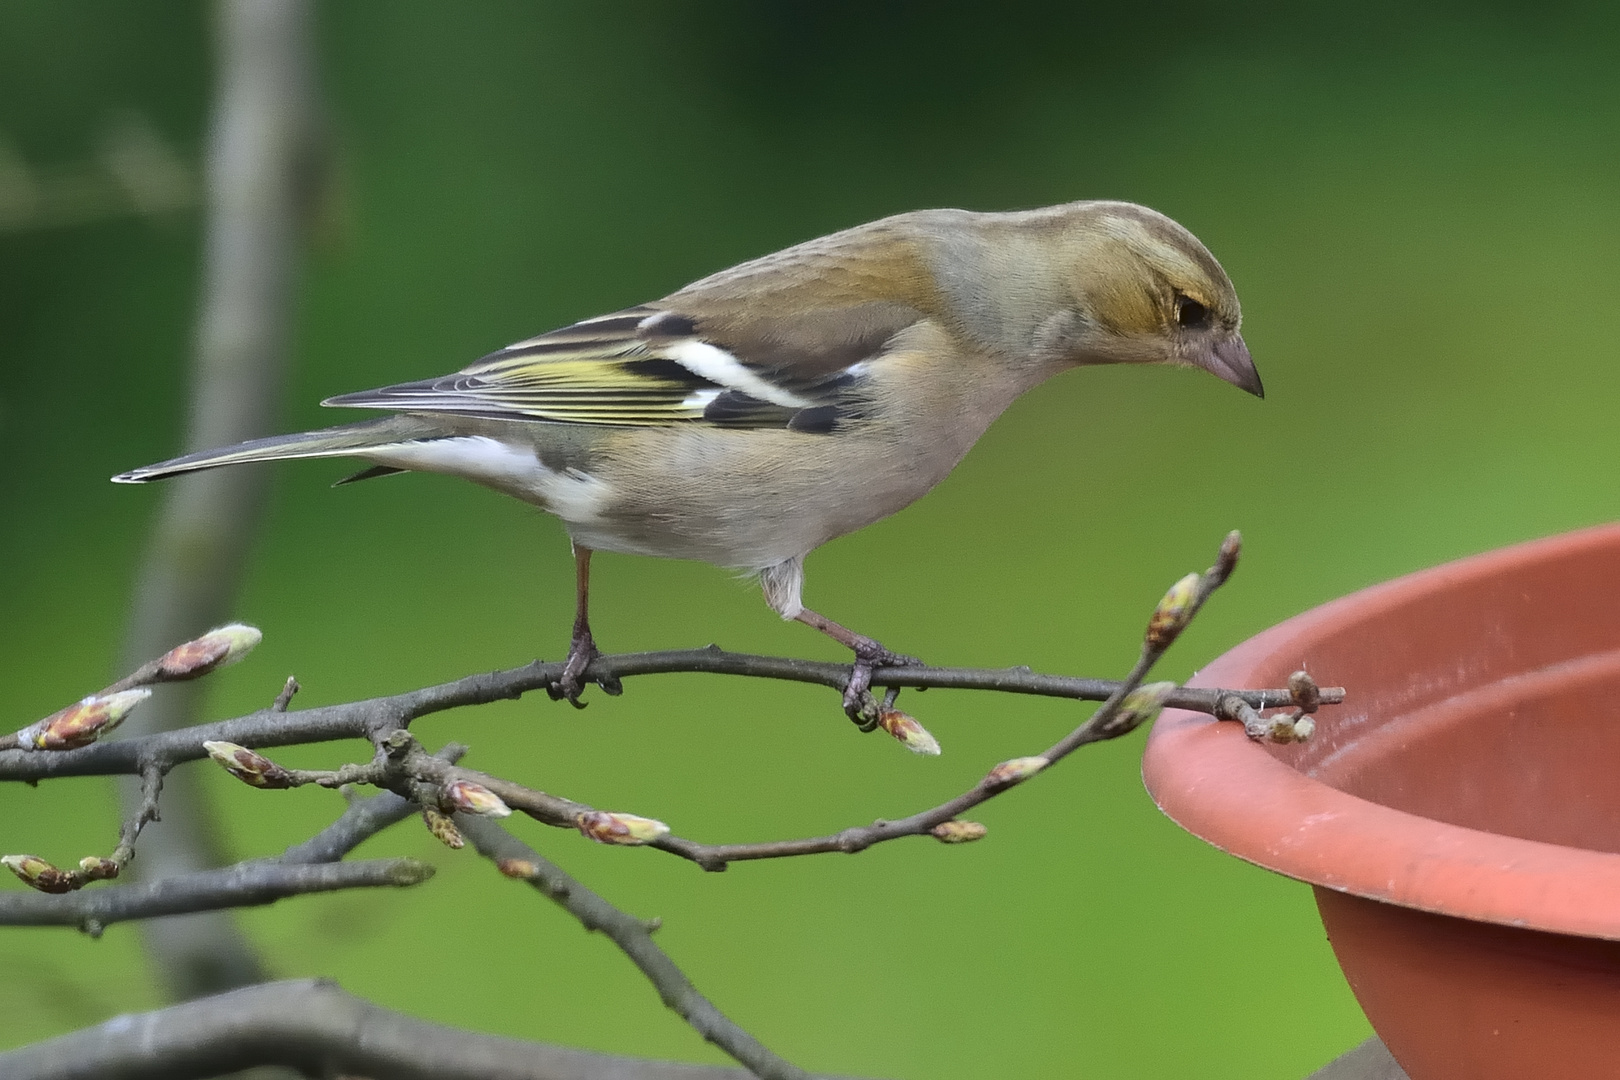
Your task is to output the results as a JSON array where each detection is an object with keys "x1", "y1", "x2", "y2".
[{"x1": 455, "y1": 814, "x2": 810, "y2": 1080}]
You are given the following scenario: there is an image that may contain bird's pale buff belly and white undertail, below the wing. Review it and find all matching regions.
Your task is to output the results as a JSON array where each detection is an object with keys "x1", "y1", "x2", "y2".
[{"x1": 374, "y1": 418, "x2": 983, "y2": 570}]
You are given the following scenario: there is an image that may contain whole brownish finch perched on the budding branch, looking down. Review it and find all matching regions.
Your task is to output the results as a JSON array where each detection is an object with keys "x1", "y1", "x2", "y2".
[{"x1": 113, "y1": 201, "x2": 1265, "y2": 719}]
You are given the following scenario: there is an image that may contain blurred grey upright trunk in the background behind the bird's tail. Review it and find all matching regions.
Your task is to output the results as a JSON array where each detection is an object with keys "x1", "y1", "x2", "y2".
[{"x1": 107, "y1": 0, "x2": 322, "y2": 997}]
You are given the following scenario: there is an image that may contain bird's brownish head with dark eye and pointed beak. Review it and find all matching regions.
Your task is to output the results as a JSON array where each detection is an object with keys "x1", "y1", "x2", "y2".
[{"x1": 1038, "y1": 202, "x2": 1265, "y2": 397}]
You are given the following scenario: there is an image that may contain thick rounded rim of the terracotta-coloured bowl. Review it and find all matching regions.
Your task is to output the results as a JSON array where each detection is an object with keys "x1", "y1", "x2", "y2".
[{"x1": 1142, "y1": 523, "x2": 1620, "y2": 939}]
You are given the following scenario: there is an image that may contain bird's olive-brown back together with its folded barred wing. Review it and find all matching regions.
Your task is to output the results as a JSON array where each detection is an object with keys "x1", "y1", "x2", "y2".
[{"x1": 326, "y1": 215, "x2": 938, "y2": 431}]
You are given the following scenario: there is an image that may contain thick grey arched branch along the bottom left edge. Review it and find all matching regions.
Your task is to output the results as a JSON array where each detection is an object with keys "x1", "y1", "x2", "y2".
[{"x1": 0, "y1": 980, "x2": 874, "y2": 1080}]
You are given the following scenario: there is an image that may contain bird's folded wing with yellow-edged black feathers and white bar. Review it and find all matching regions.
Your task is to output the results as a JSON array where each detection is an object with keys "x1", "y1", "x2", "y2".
[{"x1": 324, "y1": 303, "x2": 922, "y2": 431}]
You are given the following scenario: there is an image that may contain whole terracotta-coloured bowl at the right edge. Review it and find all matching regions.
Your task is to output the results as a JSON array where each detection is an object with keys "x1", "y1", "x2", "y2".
[{"x1": 1142, "y1": 526, "x2": 1620, "y2": 1080}]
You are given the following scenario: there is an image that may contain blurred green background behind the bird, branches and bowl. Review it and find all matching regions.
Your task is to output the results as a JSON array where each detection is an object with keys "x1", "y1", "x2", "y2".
[{"x1": 0, "y1": 0, "x2": 1620, "y2": 1080}]
